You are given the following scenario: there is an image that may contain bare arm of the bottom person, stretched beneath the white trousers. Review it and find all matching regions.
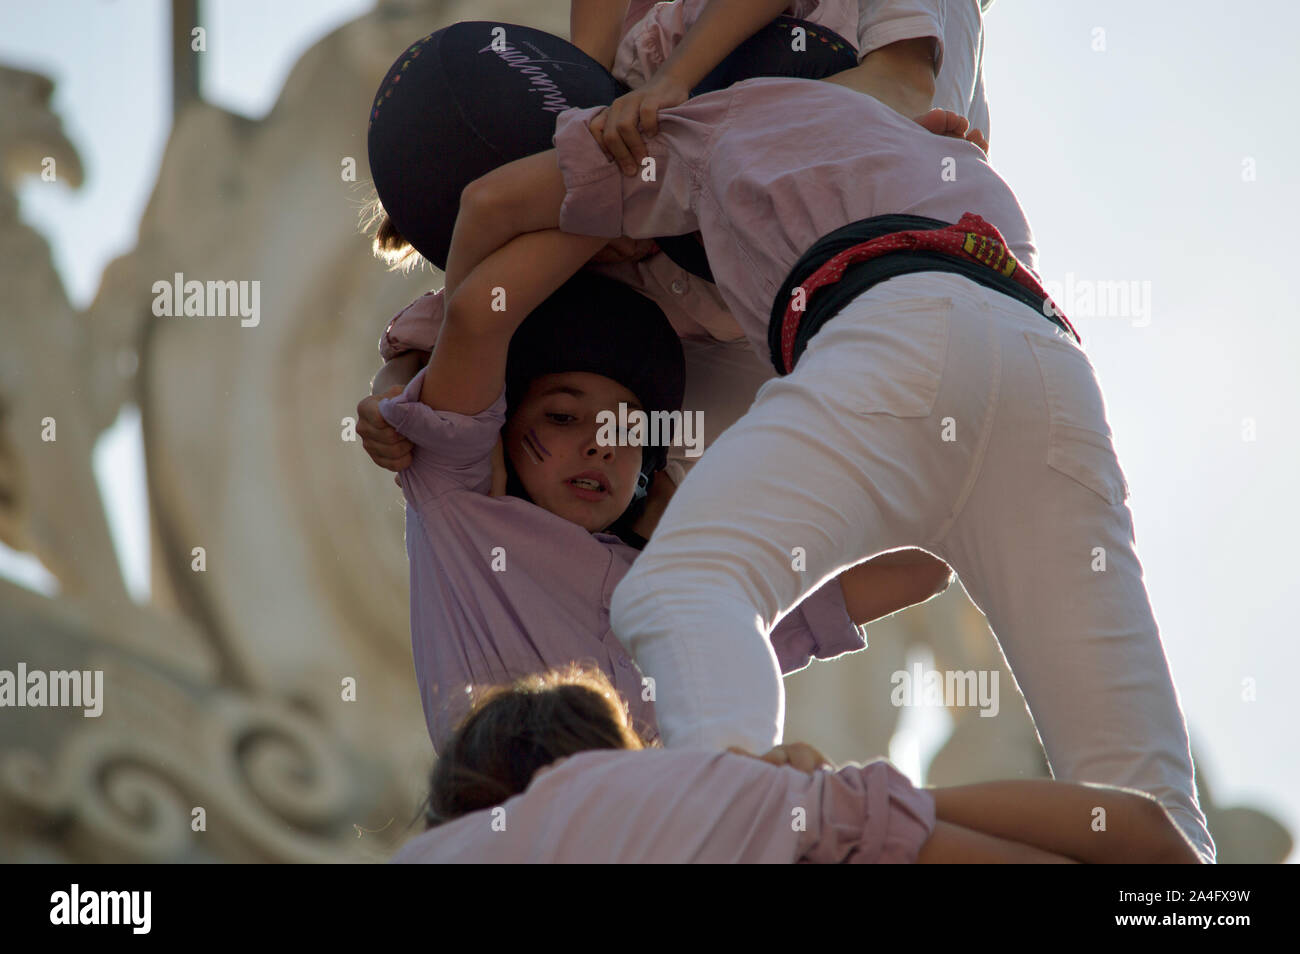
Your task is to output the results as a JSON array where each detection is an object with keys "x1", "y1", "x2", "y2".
[{"x1": 930, "y1": 779, "x2": 1197, "y2": 864}]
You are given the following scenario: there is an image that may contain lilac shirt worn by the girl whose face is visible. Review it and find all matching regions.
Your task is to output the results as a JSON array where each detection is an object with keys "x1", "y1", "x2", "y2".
[{"x1": 380, "y1": 370, "x2": 866, "y2": 749}]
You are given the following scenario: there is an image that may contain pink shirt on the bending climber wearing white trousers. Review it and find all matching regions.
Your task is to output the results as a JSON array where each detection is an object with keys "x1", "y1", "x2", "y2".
[{"x1": 555, "y1": 78, "x2": 1037, "y2": 359}]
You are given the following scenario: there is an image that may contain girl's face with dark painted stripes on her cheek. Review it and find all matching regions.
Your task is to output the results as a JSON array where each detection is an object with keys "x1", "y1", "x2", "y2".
[{"x1": 502, "y1": 372, "x2": 641, "y2": 532}]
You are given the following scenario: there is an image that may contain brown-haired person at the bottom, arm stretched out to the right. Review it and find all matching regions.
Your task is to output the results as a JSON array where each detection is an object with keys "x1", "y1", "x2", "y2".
[{"x1": 393, "y1": 671, "x2": 1196, "y2": 864}]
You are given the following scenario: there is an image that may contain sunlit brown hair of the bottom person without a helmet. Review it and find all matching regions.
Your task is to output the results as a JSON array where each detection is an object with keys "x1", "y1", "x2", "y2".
[{"x1": 425, "y1": 664, "x2": 644, "y2": 828}]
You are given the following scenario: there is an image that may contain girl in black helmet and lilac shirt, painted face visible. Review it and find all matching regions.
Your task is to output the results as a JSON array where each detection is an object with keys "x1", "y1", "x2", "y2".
[{"x1": 380, "y1": 274, "x2": 883, "y2": 751}]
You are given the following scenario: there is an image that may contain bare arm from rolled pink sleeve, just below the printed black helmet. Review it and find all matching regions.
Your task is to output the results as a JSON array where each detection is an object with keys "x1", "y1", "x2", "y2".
[{"x1": 446, "y1": 149, "x2": 566, "y2": 300}]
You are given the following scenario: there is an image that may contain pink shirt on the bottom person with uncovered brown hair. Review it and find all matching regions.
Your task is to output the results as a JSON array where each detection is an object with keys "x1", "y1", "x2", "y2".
[{"x1": 393, "y1": 749, "x2": 935, "y2": 864}]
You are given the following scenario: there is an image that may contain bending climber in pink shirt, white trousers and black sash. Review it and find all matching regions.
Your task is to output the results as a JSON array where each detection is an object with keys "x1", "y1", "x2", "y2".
[{"x1": 379, "y1": 35, "x2": 1213, "y2": 858}]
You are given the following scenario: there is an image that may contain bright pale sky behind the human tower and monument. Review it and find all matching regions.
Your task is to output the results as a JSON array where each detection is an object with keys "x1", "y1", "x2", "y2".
[{"x1": 0, "y1": 0, "x2": 1300, "y2": 868}]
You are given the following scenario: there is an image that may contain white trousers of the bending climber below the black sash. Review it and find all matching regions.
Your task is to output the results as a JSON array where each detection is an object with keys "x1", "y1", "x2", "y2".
[{"x1": 611, "y1": 273, "x2": 1214, "y2": 859}]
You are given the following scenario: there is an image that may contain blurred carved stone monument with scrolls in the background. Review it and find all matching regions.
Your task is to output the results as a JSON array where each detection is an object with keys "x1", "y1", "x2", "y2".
[{"x1": 0, "y1": 0, "x2": 1291, "y2": 862}]
